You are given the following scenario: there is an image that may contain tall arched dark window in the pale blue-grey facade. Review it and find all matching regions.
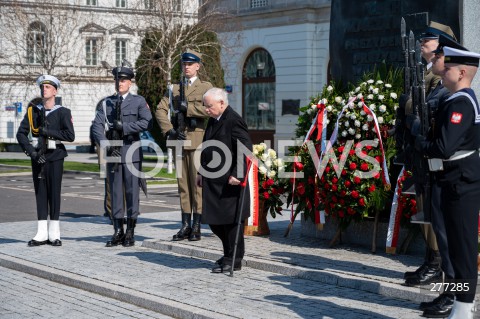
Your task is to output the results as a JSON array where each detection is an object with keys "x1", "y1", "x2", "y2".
[{"x1": 242, "y1": 49, "x2": 275, "y2": 143}]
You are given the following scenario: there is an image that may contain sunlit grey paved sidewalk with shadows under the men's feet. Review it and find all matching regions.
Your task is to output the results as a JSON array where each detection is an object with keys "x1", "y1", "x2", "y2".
[{"x1": 0, "y1": 212, "x2": 448, "y2": 319}]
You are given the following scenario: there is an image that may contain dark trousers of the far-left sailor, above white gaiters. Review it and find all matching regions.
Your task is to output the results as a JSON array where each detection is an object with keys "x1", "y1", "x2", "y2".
[{"x1": 32, "y1": 159, "x2": 63, "y2": 220}]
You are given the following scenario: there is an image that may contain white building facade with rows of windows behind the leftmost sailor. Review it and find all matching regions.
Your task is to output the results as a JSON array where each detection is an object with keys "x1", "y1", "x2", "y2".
[{"x1": 0, "y1": 0, "x2": 198, "y2": 144}]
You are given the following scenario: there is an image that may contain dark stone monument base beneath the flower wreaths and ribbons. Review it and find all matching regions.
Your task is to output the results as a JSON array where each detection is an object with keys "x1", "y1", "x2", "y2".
[{"x1": 301, "y1": 213, "x2": 425, "y2": 255}]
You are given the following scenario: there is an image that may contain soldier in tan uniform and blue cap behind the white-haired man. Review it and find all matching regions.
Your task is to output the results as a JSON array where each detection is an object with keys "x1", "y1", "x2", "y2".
[{"x1": 155, "y1": 50, "x2": 212, "y2": 241}]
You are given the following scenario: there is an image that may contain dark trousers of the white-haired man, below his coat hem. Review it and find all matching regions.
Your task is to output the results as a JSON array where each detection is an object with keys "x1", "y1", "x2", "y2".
[{"x1": 209, "y1": 222, "x2": 245, "y2": 264}]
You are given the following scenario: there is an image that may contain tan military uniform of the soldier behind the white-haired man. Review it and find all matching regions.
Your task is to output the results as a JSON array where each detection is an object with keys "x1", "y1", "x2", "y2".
[{"x1": 155, "y1": 54, "x2": 213, "y2": 240}]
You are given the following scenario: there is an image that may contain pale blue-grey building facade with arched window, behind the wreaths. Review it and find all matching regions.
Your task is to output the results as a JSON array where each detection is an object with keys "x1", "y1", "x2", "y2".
[{"x1": 220, "y1": 0, "x2": 331, "y2": 146}]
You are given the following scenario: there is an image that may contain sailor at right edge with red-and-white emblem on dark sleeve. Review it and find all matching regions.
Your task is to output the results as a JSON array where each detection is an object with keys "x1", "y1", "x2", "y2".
[{"x1": 415, "y1": 46, "x2": 480, "y2": 319}]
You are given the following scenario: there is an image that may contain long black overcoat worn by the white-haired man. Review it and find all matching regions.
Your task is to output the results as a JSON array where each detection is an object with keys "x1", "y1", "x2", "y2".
[{"x1": 201, "y1": 106, "x2": 252, "y2": 225}]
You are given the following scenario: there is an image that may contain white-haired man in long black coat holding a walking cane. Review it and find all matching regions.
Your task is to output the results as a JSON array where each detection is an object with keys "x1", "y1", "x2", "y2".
[{"x1": 197, "y1": 88, "x2": 252, "y2": 273}]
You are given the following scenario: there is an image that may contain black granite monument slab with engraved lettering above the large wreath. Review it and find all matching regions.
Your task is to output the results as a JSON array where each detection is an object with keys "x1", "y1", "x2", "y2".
[{"x1": 330, "y1": 0, "x2": 460, "y2": 84}]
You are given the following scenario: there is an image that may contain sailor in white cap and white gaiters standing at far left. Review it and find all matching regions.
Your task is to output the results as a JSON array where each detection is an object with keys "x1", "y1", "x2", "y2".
[{"x1": 17, "y1": 75, "x2": 75, "y2": 247}]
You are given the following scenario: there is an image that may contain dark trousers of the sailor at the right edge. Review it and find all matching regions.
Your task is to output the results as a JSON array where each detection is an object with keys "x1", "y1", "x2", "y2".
[{"x1": 442, "y1": 181, "x2": 480, "y2": 303}]
